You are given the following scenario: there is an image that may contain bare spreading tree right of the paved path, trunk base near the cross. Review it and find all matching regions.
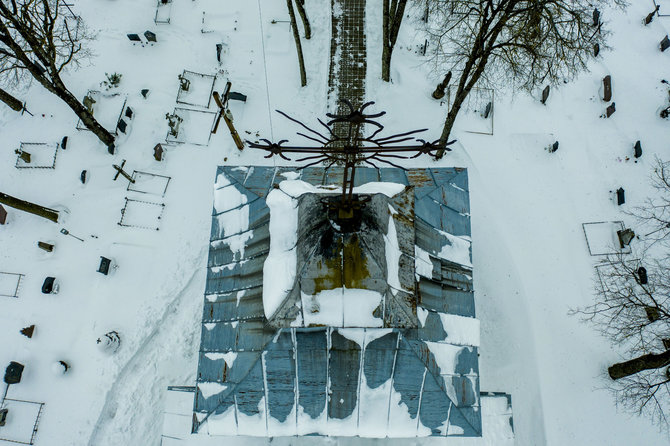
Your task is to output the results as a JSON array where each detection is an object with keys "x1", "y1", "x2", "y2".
[{"x1": 427, "y1": 0, "x2": 625, "y2": 158}]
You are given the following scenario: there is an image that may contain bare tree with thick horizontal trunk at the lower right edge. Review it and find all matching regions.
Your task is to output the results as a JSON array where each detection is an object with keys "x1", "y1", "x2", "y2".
[{"x1": 573, "y1": 251, "x2": 670, "y2": 428}]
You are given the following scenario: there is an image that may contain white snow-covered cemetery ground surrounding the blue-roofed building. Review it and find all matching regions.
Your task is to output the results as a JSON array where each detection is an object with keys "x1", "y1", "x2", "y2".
[{"x1": 0, "y1": 0, "x2": 670, "y2": 446}]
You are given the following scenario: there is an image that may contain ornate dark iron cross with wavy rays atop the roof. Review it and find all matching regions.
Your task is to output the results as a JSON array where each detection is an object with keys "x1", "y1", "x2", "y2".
[{"x1": 247, "y1": 99, "x2": 456, "y2": 220}]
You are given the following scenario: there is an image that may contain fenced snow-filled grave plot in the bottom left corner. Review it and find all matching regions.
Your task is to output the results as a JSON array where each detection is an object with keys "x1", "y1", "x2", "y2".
[{"x1": 0, "y1": 398, "x2": 44, "y2": 444}]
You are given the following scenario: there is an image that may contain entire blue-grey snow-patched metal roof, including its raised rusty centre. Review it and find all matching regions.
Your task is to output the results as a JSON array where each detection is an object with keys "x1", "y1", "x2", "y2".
[{"x1": 193, "y1": 166, "x2": 481, "y2": 437}]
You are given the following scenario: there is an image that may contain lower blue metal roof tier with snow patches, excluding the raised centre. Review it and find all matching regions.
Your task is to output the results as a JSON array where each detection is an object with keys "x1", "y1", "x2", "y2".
[{"x1": 193, "y1": 166, "x2": 481, "y2": 437}]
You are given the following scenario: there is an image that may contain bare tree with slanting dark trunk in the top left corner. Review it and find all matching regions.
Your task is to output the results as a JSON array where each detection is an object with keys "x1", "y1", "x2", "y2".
[{"x1": 0, "y1": 0, "x2": 114, "y2": 153}]
